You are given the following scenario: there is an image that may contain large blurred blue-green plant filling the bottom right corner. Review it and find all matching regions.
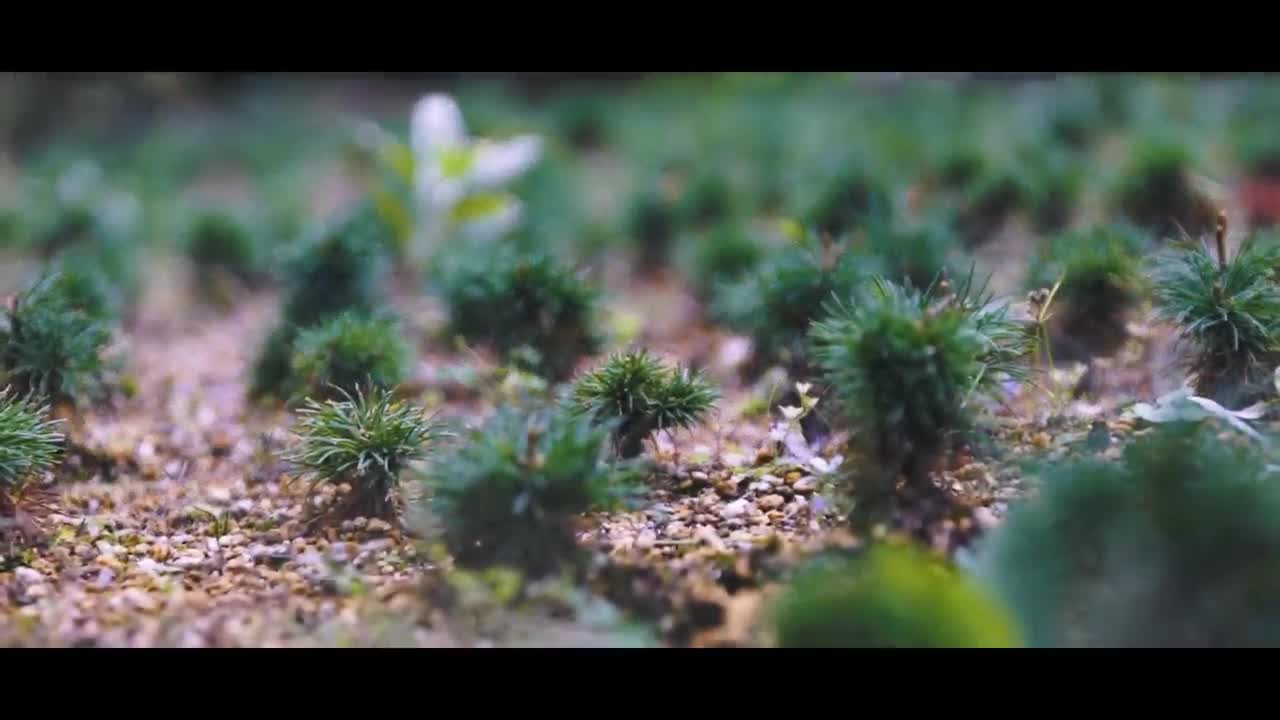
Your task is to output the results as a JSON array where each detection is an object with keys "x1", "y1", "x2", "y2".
[{"x1": 978, "y1": 423, "x2": 1280, "y2": 647}]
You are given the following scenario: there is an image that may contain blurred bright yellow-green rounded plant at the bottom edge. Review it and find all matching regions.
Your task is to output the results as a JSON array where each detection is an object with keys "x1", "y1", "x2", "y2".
[{"x1": 771, "y1": 542, "x2": 1021, "y2": 648}]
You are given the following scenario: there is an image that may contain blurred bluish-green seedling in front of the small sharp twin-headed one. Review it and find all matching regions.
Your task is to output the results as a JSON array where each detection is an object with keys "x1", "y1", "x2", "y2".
[{"x1": 424, "y1": 406, "x2": 635, "y2": 577}]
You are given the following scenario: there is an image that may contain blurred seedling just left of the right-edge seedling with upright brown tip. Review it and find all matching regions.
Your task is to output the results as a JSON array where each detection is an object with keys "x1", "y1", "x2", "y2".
[{"x1": 1027, "y1": 224, "x2": 1146, "y2": 359}]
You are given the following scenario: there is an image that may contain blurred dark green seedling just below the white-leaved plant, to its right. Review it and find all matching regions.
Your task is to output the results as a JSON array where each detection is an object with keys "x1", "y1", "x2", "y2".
[{"x1": 442, "y1": 249, "x2": 602, "y2": 380}]
